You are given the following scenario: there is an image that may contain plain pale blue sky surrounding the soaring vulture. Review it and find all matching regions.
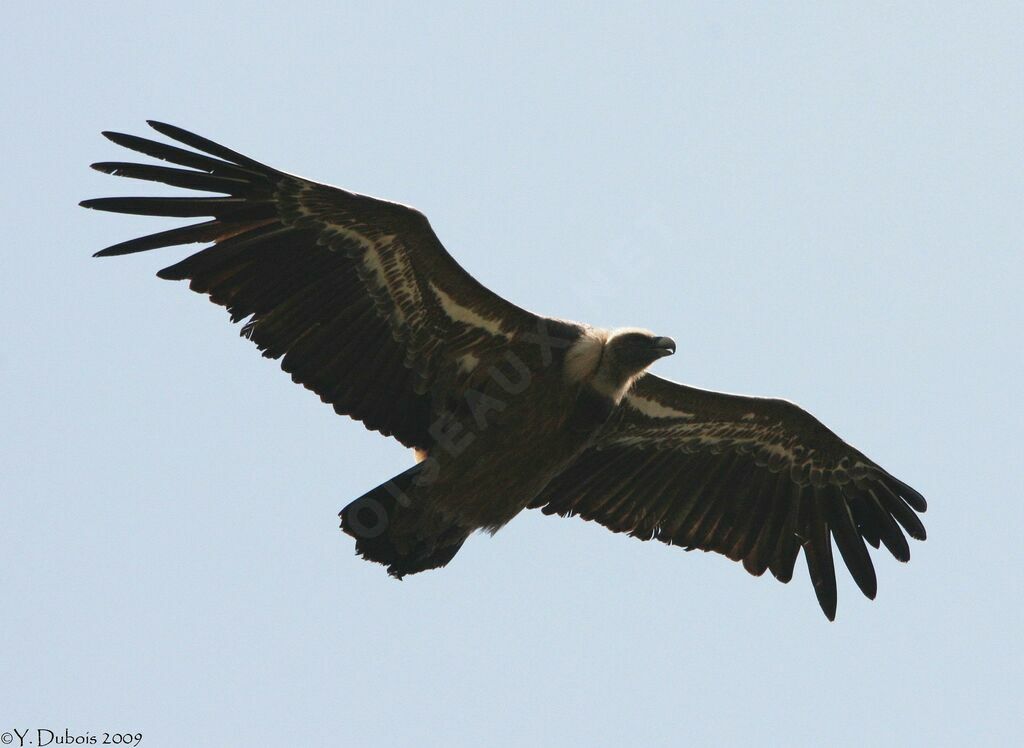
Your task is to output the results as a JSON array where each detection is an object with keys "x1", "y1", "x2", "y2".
[{"x1": 0, "y1": 1, "x2": 1024, "y2": 746}]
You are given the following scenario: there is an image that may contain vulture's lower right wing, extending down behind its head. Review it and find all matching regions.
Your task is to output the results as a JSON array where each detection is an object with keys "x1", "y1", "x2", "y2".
[{"x1": 532, "y1": 374, "x2": 927, "y2": 620}]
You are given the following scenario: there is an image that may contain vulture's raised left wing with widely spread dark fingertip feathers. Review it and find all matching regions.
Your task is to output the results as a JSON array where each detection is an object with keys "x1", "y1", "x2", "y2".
[{"x1": 82, "y1": 122, "x2": 561, "y2": 449}]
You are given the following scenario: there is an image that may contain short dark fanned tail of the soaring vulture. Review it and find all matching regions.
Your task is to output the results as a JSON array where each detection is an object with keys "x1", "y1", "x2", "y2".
[{"x1": 339, "y1": 462, "x2": 470, "y2": 579}]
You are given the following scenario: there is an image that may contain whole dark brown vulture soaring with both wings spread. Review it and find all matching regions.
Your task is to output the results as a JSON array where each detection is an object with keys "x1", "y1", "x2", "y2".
[{"x1": 81, "y1": 122, "x2": 926, "y2": 620}]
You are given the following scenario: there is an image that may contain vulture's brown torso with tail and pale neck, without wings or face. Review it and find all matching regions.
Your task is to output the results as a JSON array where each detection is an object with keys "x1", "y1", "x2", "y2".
[{"x1": 342, "y1": 321, "x2": 667, "y2": 577}]
